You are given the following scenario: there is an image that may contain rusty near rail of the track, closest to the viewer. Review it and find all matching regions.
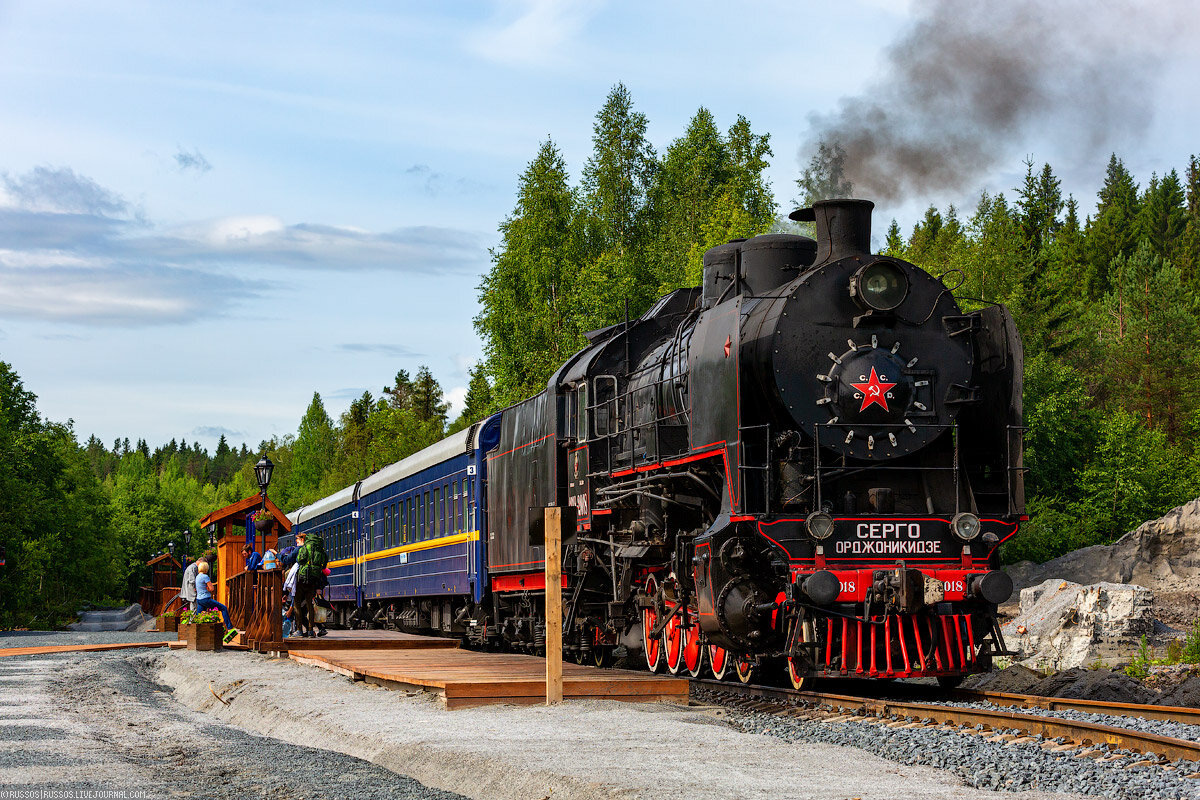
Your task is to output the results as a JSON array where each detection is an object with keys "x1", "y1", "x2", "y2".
[{"x1": 691, "y1": 679, "x2": 1200, "y2": 762}]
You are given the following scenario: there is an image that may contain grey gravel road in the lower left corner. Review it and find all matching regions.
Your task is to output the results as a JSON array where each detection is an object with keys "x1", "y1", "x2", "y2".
[{"x1": 0, "y1": 652, "x2": 461, "y2": 800}]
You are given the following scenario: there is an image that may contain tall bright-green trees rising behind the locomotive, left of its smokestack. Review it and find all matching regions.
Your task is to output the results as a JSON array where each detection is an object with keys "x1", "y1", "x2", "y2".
[{"x1": 477, "y1": 84, "x2": 775, "y2": 407}]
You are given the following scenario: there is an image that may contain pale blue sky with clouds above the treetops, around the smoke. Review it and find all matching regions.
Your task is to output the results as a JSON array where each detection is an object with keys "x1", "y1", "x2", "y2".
[{"x1": 0, "y1": 0, "x2": 1200, "y2": 449}]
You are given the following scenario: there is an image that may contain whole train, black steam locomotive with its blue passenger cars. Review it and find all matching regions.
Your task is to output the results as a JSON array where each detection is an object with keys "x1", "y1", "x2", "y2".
[{"x1": 290, "y1": 200, "x2": 1025, "y2": 687}]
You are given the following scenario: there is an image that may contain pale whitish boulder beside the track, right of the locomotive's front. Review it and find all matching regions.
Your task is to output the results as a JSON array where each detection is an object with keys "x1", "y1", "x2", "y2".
[{"x1": 1003, "y1": 579, "x2": 1154, "y2": 670}]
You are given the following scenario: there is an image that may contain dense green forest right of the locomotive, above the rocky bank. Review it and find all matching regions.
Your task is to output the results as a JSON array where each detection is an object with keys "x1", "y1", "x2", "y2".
[{"x1": 886, "y1": 156, "x2": 1200, "y2": 561}]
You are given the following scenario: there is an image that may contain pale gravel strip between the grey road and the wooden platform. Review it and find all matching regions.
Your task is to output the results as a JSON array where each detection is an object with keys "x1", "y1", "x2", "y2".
[{"x1": 157, "y1": 651, "x2": 1099, "y2": 800}]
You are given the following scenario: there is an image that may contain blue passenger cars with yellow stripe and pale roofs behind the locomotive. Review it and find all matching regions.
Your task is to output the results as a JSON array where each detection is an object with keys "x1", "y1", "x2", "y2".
[{"x1": 281, "y1": 415, "x2": 500, "y2": 631}]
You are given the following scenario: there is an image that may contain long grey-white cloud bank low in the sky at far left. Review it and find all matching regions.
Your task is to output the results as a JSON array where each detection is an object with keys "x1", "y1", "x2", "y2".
[{"x1": 0, "y1": 167, "x2": 488, "y2": 326}]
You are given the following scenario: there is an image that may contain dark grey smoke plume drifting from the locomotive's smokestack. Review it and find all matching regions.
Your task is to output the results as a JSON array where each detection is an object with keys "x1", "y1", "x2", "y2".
[{"x1": 800, "y1": 0, "x2": 1198, "y2": 201}]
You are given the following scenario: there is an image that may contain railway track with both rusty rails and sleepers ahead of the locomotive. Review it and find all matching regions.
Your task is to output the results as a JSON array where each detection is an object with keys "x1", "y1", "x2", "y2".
[{"x1": 692, "y1": 680, "x2": 1200, "y2": 777}]
